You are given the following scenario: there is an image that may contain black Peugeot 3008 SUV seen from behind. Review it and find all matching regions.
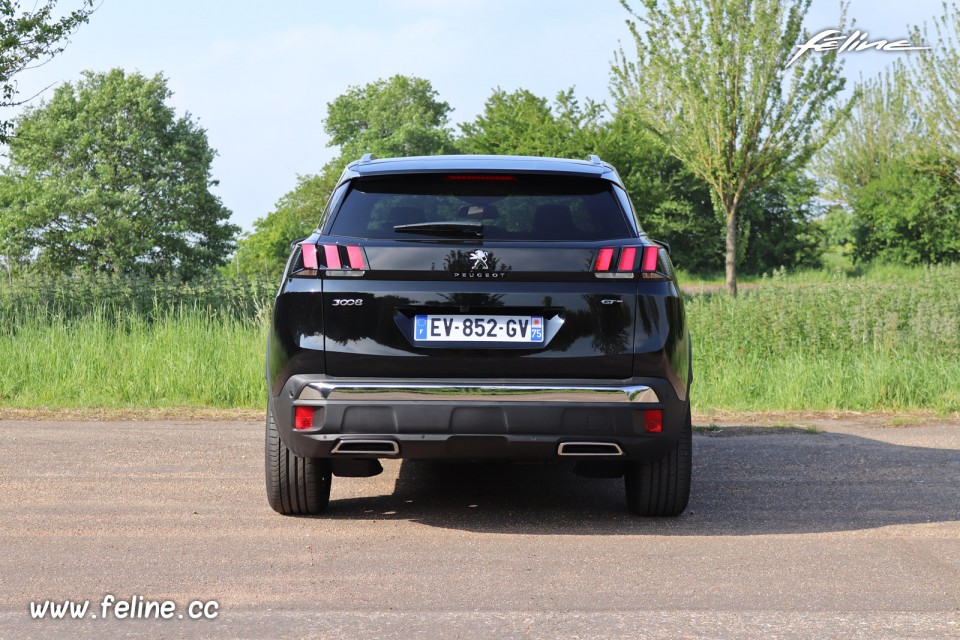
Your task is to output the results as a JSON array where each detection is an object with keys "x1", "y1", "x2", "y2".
[{"x1": 266, "y1": 155, "x2": 692, "y2": 516}]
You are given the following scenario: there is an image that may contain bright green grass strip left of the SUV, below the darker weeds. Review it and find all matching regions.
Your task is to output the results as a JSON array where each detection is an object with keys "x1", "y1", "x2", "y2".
[{"x1": 0, "y1": 308, "x2": 266, "y2": 408}]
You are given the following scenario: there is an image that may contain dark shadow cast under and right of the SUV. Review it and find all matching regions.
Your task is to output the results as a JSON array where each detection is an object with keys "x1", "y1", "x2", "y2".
[{"x1": 326, "y1": 427, "x2": 960, "y2": 536}]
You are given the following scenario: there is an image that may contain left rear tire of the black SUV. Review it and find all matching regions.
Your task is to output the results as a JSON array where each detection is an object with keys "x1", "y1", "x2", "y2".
[{"x1": 264, "y1": 407, "x2": 331, "y2": 516}]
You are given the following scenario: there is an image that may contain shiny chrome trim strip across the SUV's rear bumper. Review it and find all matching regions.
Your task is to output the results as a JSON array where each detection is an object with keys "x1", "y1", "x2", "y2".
[{"x1": 297, "y1": 382, "x2": 660, "y2": 404}]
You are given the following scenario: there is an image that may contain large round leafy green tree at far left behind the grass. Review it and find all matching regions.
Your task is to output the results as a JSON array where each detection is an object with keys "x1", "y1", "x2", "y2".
[{"x1": 0, "y1": 69, "x2": 237, "y2": 278}]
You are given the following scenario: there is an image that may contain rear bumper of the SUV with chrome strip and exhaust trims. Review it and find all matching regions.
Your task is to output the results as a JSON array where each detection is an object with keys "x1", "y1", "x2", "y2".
[{"x1": 270, "y1": 375, "x2": 687, "y2": 460}]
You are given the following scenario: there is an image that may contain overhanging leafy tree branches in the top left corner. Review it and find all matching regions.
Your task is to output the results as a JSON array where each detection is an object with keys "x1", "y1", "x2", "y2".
[{"x1": 0, "y1": 0, "x2": 93, "y2": 143}]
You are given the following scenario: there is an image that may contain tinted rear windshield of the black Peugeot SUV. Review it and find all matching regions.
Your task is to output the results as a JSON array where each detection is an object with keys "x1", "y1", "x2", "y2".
[{"x1": 330, "y1": 174, "x2": 632, "y2": 242}]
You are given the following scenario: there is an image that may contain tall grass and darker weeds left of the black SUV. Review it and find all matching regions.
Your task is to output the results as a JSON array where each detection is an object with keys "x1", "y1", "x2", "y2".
[{"x1": 0, "y1": 277, "x2": 277, "y2": 408}]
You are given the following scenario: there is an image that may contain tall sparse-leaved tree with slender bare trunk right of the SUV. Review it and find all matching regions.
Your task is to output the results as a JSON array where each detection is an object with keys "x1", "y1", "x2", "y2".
[{"x1": 612, "y1": 0, "x2": 849, "y2": 295}]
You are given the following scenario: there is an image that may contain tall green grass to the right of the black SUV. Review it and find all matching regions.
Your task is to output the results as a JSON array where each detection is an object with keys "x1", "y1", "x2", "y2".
[{"x1": 687, "y1": 266, "x2": 960, "y2": 412}]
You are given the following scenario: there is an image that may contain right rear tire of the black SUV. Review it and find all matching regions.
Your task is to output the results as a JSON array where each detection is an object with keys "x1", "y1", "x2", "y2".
[{"x1": 624, "y1": 407, "x2": 693, "y2": 517}]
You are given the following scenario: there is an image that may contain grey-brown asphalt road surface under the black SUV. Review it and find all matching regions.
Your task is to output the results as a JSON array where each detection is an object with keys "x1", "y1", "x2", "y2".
[{"x1": 0, "y1": 420, "x2": 960, "y2": 640}]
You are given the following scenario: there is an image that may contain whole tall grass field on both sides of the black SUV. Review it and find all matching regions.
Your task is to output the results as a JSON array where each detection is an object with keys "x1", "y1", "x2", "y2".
[{"x1": 0, "y1": 266, "x2": 960, "y2": 413}]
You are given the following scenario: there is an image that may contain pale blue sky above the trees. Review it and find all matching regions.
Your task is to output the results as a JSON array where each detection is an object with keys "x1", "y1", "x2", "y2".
[{"x1": 2, "y1": 0, "x2": 941, "y2": 230}]
